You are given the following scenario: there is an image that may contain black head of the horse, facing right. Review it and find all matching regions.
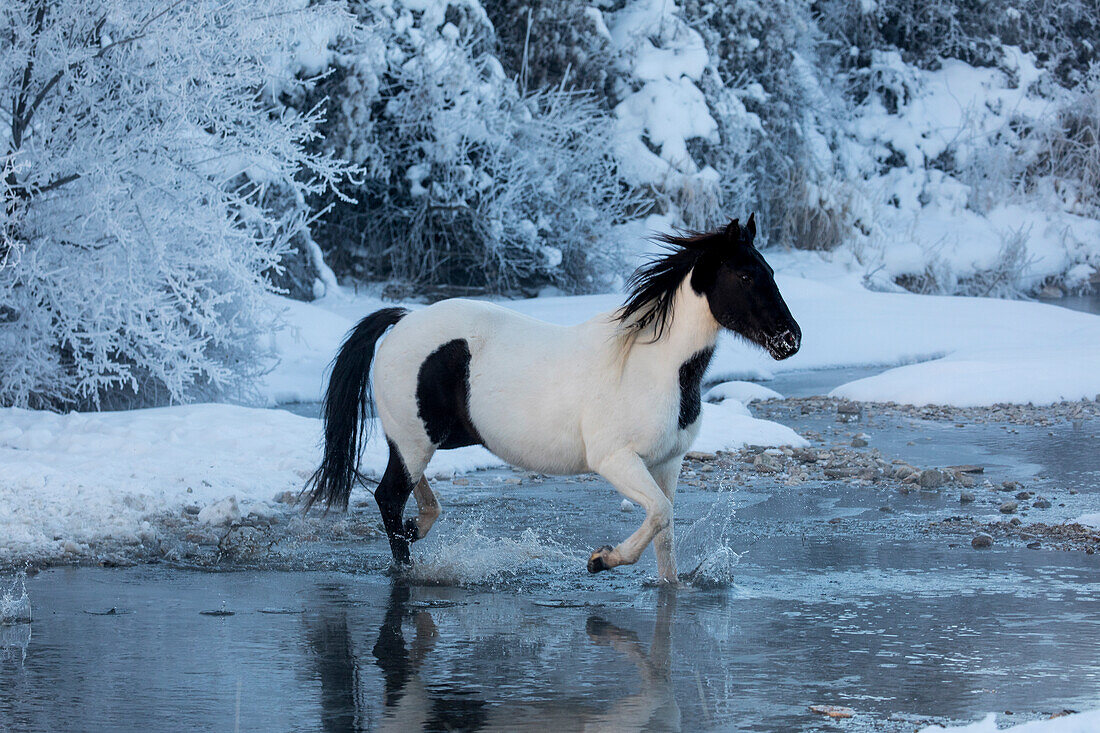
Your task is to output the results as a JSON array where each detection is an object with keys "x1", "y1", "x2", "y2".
[{"x1": 691, "y1": 214, "x2": 802, "y2": 359}]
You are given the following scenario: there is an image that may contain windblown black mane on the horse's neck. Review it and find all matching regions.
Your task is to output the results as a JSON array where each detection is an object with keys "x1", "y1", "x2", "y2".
[{"x1": 617, "y1": 229, "x2": 727, "y2": 340}]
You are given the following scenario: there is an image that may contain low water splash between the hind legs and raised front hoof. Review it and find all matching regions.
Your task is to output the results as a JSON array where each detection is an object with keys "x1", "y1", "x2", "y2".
[{"x1": 408, "y1": 512, "x2": 587, "y2": 586}]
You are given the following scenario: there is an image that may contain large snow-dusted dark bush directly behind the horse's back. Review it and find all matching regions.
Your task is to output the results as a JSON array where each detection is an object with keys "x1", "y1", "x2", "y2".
[{"x1": 305, "y1": 0, "x2": 634, "y2": 292}]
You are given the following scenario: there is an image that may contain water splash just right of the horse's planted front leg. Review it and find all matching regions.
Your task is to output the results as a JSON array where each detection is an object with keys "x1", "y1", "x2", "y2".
[{"x1": 677, "y1": 488, "x2": 741, "y2": 588}]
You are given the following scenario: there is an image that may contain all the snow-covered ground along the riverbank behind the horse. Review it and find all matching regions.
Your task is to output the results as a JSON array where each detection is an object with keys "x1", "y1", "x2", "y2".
[{"x1": 0, "y1": 254, "x2": 1100, "y2": 560}]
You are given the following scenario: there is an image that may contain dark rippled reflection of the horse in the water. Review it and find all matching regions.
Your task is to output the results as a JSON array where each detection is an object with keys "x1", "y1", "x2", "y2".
[{"x1": 309, "y1": 582, "x2": 681, "y2": 733}]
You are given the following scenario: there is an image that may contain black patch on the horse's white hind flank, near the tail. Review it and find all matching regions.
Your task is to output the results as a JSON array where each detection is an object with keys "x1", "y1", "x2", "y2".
[{"x1": 416, "y1": 339, "x2": 482, "y2": 448}]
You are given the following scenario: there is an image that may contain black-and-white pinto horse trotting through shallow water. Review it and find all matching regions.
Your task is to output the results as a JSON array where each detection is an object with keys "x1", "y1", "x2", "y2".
[{"x1": 304, "y1": 215, "x2": 802, "y2": 583}]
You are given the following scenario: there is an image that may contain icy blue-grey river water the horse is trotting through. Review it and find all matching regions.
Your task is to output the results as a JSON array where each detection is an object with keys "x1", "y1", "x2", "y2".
[{"x1": 0, "y1": 374, "x2": 1100, "y2": 733}]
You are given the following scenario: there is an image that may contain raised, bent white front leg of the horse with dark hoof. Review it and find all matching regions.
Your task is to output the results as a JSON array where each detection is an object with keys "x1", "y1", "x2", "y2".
[{"x1": 589, "y1": 450, "x2": 672, "y2": 572}]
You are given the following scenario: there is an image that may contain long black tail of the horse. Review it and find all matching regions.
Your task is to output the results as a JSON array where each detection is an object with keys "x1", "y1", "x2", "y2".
[{"x1": 303, "y1": 308, "x2": 408, "y2": 512}]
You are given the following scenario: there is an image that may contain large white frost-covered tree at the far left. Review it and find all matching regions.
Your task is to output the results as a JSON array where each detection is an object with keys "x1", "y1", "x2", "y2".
[{"x1": 0, "y1": 0, "x2": 347, "y2": 408}]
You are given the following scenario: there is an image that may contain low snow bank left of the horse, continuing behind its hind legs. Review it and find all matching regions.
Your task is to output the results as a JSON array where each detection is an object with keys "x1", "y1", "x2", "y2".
[{"x1": 0, "y1": 405, "x2": 501, "y2": 561}]
